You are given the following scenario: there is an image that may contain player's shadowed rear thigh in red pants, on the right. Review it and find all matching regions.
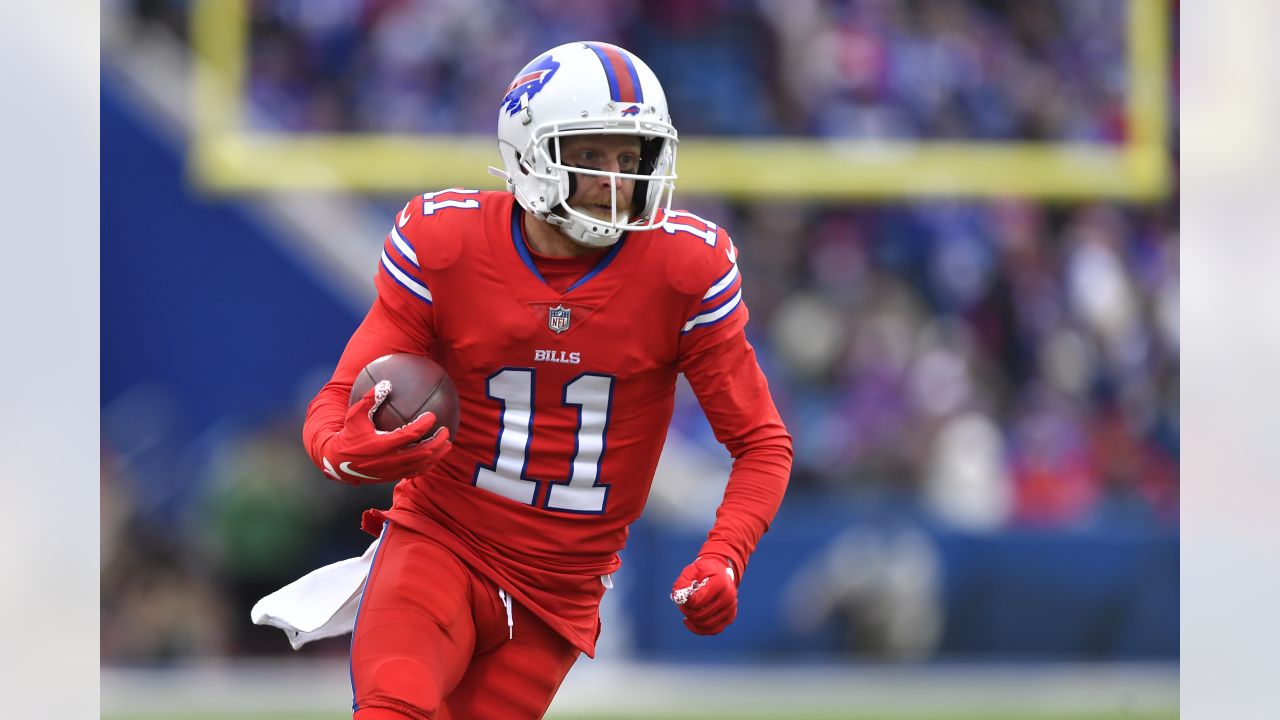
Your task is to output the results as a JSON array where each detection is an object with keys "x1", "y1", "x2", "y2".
[{"x1": 444, "y1": 605, "x2": 579, "y2": 720}]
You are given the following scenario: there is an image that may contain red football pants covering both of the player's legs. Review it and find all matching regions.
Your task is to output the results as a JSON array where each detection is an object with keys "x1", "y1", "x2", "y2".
[{"x1": 351, "y1": 523, "x2": 579, "y2": 720}]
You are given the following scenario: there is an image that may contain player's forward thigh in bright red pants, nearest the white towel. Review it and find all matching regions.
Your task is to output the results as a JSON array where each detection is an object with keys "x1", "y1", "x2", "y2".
[{"x1": 351, "y1": 524, "x2": 475, "y2": 720}]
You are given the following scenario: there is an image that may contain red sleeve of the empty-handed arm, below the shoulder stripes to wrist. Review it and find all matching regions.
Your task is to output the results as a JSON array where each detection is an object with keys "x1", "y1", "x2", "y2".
[{"x1": 680, "y1": 324, "x2": 792, "y2": 582}]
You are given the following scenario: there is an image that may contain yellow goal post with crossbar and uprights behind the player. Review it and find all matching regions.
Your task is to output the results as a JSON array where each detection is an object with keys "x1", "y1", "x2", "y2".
[{"x1": 188, "y1": 0, "x2": 1170, "y2": 201}]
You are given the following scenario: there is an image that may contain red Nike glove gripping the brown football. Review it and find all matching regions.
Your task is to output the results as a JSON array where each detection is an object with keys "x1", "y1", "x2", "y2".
[{"x1": 320, "y1": 380, "x2": 453, "y2": 486}]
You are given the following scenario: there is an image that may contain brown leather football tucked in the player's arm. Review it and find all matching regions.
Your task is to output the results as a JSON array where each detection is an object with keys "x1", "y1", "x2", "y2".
[{"x1": 351, "y1": 352, "x2": 458, "y2": 438}]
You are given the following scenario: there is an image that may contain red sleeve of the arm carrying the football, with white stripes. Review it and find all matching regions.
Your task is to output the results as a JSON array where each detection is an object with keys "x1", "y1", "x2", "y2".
[{"x1": 302, "y1": 207, "x2": 435, "y2": 470}]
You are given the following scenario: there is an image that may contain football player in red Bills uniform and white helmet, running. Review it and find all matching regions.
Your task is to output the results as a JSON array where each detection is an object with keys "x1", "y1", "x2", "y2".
[{"x1": 303, "y1": 42, "x2": 791, "y2": 720}]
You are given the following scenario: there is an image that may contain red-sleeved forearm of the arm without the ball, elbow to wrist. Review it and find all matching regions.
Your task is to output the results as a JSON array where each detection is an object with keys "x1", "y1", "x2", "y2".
[{"x1": 699, "y1": 430, "x2": 792, "y2": 580}]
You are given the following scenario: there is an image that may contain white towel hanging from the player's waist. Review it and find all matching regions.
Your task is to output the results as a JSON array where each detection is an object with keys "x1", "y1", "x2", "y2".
[{"x1": 250, "y1": 538, "x2": 381, "y2": 650}]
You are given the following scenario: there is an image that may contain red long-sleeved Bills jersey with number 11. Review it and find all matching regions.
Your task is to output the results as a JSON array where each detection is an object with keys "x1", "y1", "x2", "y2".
[{"x1": 303, "y1": 190, "x2": 791, "y2": 656}]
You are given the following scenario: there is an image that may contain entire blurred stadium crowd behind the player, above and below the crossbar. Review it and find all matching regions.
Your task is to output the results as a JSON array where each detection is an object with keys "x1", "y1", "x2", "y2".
[{"x1": 102, "y1": 0, "x2": 1179, "y2": 660}]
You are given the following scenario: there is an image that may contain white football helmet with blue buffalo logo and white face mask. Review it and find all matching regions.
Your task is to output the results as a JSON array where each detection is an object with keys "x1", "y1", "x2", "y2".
[{"x1": 494, "y1": 42, "x2": 677, "y2": 247}]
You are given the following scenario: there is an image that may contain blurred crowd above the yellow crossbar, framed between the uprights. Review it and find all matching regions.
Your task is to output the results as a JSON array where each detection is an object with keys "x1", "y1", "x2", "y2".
[{"x1": 133, "y1": 0, "x2": 1126, "y2": 142}]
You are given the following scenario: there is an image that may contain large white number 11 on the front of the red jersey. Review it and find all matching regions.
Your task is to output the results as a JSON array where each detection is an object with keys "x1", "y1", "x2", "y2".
[{"x1": 475, "y1": 368, "x2": 613, "y2": 514}]
